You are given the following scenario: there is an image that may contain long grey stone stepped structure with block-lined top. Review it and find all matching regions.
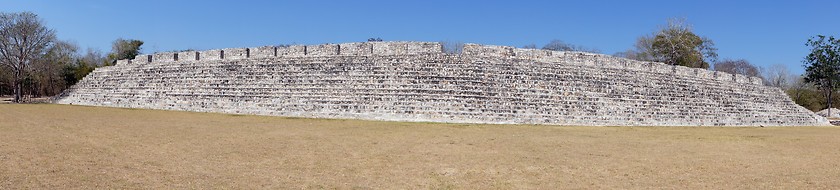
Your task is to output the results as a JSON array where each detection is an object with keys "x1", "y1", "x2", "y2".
[{"x1": 55, "y1": 41, "x2": 829, "y2": 126}]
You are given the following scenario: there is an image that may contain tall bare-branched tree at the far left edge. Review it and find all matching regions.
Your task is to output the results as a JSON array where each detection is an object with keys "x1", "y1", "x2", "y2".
[{"x1": 0, "y1": 12, "x2": 55, "y2": 102}]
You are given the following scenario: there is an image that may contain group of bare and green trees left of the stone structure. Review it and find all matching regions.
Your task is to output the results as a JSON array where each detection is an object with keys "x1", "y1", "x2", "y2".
[{"x1": 0, "y1": 12, "x2": 143, "y2": 102}]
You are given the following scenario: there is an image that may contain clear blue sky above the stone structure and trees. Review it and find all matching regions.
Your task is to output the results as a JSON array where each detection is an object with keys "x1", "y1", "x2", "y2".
[{"x1": 0, "y1": 0, "x2": 840, "y2": 73}]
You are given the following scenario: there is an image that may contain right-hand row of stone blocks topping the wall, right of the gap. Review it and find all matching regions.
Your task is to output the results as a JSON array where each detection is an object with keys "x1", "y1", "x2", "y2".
[{"x1": 462, "y1": 43, "x2": 763, "y2": 85}]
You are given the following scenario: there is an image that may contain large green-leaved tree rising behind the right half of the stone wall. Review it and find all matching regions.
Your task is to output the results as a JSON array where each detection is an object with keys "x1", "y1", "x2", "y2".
[{"x1": 616, "y1": 18, "x2": 717, "y2": 68}]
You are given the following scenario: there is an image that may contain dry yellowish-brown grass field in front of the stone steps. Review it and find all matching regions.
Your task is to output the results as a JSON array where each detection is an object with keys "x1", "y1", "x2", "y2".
[{"x1": 0, "y1": 104, "x2": 840, "y2": 189}]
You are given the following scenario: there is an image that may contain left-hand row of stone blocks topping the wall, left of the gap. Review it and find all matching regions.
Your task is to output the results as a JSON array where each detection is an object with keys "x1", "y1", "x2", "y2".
[{"x1": 117, "y1": 41, "x2": 443, "y2": 65}]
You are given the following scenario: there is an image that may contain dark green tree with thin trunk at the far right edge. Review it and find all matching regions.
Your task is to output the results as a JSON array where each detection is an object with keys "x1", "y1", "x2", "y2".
[{"x1": 803, "y1": 35, "x2": 840, "y2": 115}]
